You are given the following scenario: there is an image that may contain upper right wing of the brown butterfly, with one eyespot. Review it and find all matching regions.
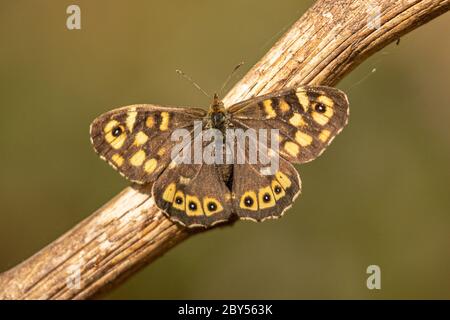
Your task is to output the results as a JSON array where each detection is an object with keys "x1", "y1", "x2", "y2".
[{"x1": 228, "y1": 86, "x2": 349, "y2": 163}]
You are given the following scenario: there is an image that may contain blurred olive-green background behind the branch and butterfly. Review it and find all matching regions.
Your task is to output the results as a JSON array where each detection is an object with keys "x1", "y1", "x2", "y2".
[{"x1": 0, "y1": 0, "x2": 450, "y2": 299}]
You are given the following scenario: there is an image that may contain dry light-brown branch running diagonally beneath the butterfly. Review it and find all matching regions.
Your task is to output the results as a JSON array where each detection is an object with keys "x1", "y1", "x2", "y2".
[{"x1": 0, "y1": 0, "x2": 450, "y2": 299}]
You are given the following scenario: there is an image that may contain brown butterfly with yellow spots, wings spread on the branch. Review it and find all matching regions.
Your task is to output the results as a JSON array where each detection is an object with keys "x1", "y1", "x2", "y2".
[{"x1": 90, "y1": 86, "x2": 349, "y2": 228}]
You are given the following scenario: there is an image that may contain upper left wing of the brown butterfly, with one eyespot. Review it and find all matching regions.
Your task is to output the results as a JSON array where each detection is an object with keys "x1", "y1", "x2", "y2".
[{"x1": 90, "y1": 104, "x2": 206, "y2": 184}]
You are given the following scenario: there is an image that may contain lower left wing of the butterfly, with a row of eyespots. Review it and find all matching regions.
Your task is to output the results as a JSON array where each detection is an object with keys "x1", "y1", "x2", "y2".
[{"x1": 152, "y1": 140, "x2": 232, "y2": 227}]
